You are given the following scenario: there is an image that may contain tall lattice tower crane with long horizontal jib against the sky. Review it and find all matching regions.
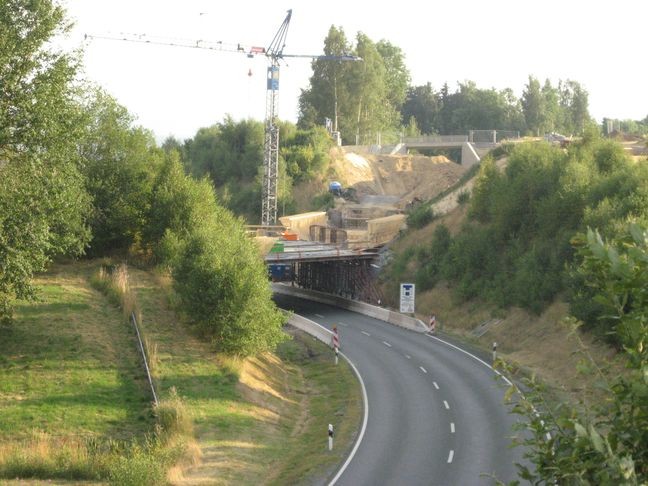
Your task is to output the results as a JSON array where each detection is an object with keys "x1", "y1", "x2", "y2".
[{"x1": 86, "y1": 9, "x2": 362, "y2": 226}]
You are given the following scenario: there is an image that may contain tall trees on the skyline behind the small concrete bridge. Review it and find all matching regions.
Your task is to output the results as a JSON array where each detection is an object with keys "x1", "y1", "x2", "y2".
[{"x1": 298, "y1": 26, "x2": 608, "y2": 144}]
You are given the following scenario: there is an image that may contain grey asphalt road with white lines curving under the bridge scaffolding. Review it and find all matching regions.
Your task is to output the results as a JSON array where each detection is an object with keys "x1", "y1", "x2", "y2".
[{"x1": 275, "y1": 295, "x2": 523, "y2": 486}]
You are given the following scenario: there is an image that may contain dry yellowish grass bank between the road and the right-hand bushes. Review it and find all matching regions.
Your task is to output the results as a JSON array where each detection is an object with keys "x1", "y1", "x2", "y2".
[{"x1": 382, "y1": 145, "x2": 623, "y2": 401}]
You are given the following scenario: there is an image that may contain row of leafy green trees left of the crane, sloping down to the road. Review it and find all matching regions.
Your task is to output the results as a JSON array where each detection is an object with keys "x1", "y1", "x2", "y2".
[{"x1": 0, "y1": 0, "x2": 283, "y2": 355}]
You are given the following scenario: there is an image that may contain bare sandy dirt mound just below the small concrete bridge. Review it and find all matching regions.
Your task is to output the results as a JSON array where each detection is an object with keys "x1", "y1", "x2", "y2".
[{"x1": 332, "y1": 152, "x2": 466, "y2": 208}]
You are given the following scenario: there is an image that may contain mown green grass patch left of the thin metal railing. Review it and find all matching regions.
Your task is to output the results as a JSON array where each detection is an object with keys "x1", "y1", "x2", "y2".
[{"x1": 0, "y1": 264, "x2": 151, "y2": 441}]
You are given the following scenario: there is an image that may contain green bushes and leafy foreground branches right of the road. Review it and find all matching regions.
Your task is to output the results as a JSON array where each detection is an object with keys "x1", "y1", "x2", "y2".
[{"x1": 383, "y1": 134, "x2": 648, "y2": 485}]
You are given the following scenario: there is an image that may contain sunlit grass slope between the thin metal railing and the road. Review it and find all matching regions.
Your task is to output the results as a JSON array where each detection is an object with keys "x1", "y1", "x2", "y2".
[{"x1": 111, "y1": 269, "x2": 361, "y2": 484}]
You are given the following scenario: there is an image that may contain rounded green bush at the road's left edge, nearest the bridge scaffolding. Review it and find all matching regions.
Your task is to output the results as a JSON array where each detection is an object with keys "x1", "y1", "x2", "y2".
[{"x1": 172, "y1": 218, "x2": 284, "y2": 355}]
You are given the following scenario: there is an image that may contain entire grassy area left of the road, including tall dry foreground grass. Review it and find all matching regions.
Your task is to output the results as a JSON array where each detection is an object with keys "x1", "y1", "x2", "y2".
[{"x1": 0, "y1": 262, "x2": 362, "y2": 485}]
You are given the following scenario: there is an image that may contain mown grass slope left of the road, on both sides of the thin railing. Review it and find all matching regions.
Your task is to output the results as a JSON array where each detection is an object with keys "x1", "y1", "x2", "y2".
[{"x1": 0, "y1": 263, "x2": 362, "y2": 484}]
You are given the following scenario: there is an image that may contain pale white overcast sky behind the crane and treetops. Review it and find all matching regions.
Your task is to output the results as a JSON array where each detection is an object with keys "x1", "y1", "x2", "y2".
[{"x1": 59, "y1": 0, "x2": 648, "y2": 141}]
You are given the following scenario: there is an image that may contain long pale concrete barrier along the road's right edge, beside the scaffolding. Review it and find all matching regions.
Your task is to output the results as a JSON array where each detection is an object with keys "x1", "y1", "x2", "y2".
[{"x1": 272, "y1": 283, "x2": 428, "y2": 333}]
